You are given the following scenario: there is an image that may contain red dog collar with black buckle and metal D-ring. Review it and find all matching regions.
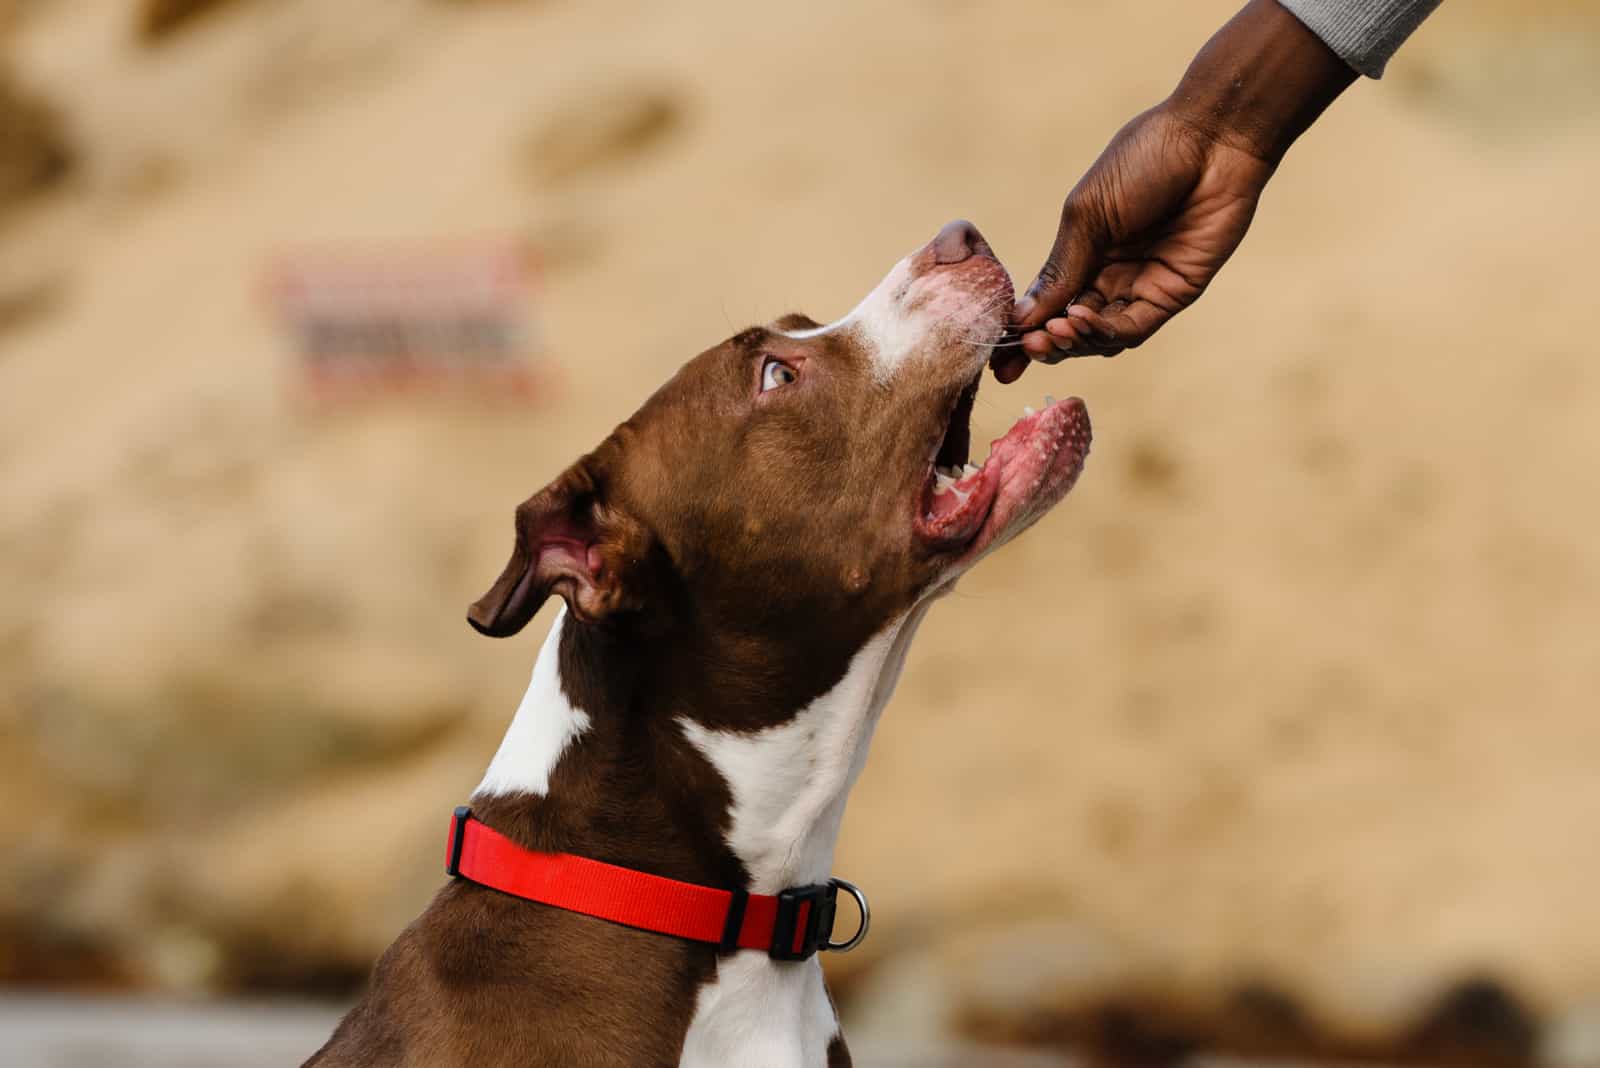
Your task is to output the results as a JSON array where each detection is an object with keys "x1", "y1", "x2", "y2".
[{"x1": 445, "y1": 806, "x2": 872, "y2": 961}]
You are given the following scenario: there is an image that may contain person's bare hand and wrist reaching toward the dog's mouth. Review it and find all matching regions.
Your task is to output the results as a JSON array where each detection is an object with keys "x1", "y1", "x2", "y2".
[{"x1": 990, "y1": 0, "x2": 1355, "y2": 382}]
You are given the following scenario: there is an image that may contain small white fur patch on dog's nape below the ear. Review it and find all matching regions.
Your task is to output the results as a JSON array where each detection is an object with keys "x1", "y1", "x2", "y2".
[{"x1": 472, "y1": 606, "x2": 589, "y2": 798}]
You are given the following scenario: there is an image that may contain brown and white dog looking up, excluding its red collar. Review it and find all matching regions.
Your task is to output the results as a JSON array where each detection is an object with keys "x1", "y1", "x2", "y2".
[{"x1": 307, "y1": 222, "x2": 1090, "y2": 1068}]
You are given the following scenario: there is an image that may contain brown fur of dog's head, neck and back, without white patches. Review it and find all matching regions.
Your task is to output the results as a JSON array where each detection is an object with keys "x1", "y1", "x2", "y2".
[{"x1": 309, "y1": 254, "x2": 992, "y2": 1068}]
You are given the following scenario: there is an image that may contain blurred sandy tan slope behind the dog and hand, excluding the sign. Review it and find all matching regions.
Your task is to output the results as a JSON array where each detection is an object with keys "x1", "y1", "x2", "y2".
[{"x1": 0, "y1": 0, "x2": 1600, "y2": 1066}]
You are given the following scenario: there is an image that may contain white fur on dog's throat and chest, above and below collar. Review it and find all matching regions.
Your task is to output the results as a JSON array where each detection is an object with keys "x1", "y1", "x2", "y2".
[{"x1": 680, "y1": 601, "x2": 928, "y2": 1068}]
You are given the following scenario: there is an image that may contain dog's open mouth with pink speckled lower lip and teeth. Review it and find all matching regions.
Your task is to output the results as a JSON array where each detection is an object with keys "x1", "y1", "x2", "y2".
[{"x1": 915, "y1": 373, "x2": 1091, "y2": 553}]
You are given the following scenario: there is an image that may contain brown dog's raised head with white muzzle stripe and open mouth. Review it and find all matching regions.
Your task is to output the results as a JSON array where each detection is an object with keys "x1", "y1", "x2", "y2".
[{"x1": 467, "y1": 222, "x2": 1090, "y2": 697}]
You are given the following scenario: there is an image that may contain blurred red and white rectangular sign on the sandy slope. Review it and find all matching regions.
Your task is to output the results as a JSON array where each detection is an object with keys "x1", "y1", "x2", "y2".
[{"x1": 269, "y1": 241, "x2": 544, "y2": 398}]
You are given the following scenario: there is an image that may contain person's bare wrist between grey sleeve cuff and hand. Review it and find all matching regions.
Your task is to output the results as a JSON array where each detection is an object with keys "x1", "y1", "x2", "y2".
[{"x1": 1163, "y1": 0, "x2": 1355, "y2": 165}]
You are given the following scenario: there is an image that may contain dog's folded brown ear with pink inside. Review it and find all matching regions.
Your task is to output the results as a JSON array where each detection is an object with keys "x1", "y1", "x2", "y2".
[{"x1": 467, "y1": 459, "x2": 648, "y2": 638}]
